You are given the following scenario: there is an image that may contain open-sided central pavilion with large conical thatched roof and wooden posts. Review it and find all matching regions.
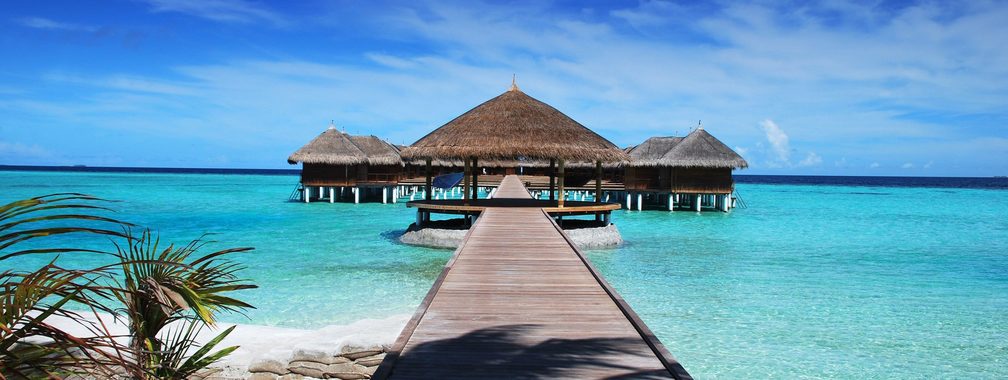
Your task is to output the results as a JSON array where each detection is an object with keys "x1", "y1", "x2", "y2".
[{"x1": 401, "y1": 80, "x2": 629, "y2": 225}]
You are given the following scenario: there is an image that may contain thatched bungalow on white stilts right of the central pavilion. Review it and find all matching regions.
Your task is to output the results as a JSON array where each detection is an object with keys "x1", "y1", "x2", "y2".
[{"x1": 624, "y1": 127, "x2": 749, "y2": 212}]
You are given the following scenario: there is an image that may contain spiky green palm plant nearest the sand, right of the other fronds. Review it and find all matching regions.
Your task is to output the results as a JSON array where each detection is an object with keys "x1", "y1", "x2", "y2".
[{"x1": 115, "y1": 230, "x2": 256, "y2": 379}]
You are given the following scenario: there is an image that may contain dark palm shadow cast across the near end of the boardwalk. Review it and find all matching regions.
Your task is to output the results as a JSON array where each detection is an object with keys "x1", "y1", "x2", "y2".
[{"x1": 383, "y1": 325, "x2": 670, "y2": 379}]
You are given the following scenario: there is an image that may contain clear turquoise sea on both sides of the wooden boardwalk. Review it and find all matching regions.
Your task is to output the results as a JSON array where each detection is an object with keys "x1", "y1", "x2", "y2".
[{"x1": 0, "y1": 171, "x2": 1008, "y2": 379}]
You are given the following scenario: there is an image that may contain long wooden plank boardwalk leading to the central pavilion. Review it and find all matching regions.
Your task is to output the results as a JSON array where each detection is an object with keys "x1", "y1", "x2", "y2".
[{"x1": 374, "y1": 175, "x2": 690, "y2": 379}]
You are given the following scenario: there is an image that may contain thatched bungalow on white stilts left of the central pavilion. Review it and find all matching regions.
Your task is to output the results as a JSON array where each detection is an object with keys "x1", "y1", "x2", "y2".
[{"x1": 287, "y1": 125, "x2": 403, "y2": 203}]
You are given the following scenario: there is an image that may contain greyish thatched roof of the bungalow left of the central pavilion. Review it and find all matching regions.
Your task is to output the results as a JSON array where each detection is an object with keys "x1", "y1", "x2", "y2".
[{"x1": 287, "y1": 125, "x2": 402, "y2": 165}]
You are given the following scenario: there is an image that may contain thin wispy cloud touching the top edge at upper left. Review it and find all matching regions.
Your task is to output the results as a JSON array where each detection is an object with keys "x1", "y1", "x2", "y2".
[{"x1": 145, "y1": 0, "x2": 286, "y2": 25}]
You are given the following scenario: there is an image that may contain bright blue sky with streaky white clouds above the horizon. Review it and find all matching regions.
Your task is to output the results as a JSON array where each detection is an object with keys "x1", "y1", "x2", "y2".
[{"x1": 0, "y1": 0, "x2": 1008, "y2": 176}]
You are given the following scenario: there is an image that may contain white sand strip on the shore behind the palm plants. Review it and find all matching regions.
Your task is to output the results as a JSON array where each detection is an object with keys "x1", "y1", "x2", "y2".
[{"x1": 49, "y1": 314, "x2": 410, "y2": 373}]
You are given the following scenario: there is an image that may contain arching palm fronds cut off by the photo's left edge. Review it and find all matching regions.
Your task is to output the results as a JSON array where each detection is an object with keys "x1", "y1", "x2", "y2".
[{"x1": 0, "y1": 194, "x2": 137, "y2": 379}]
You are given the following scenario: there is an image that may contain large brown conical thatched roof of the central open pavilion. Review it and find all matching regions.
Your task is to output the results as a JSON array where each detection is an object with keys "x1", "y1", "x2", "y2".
[{"x1": 402, "y1": 86, "x2": 628, "y2": 161}]
